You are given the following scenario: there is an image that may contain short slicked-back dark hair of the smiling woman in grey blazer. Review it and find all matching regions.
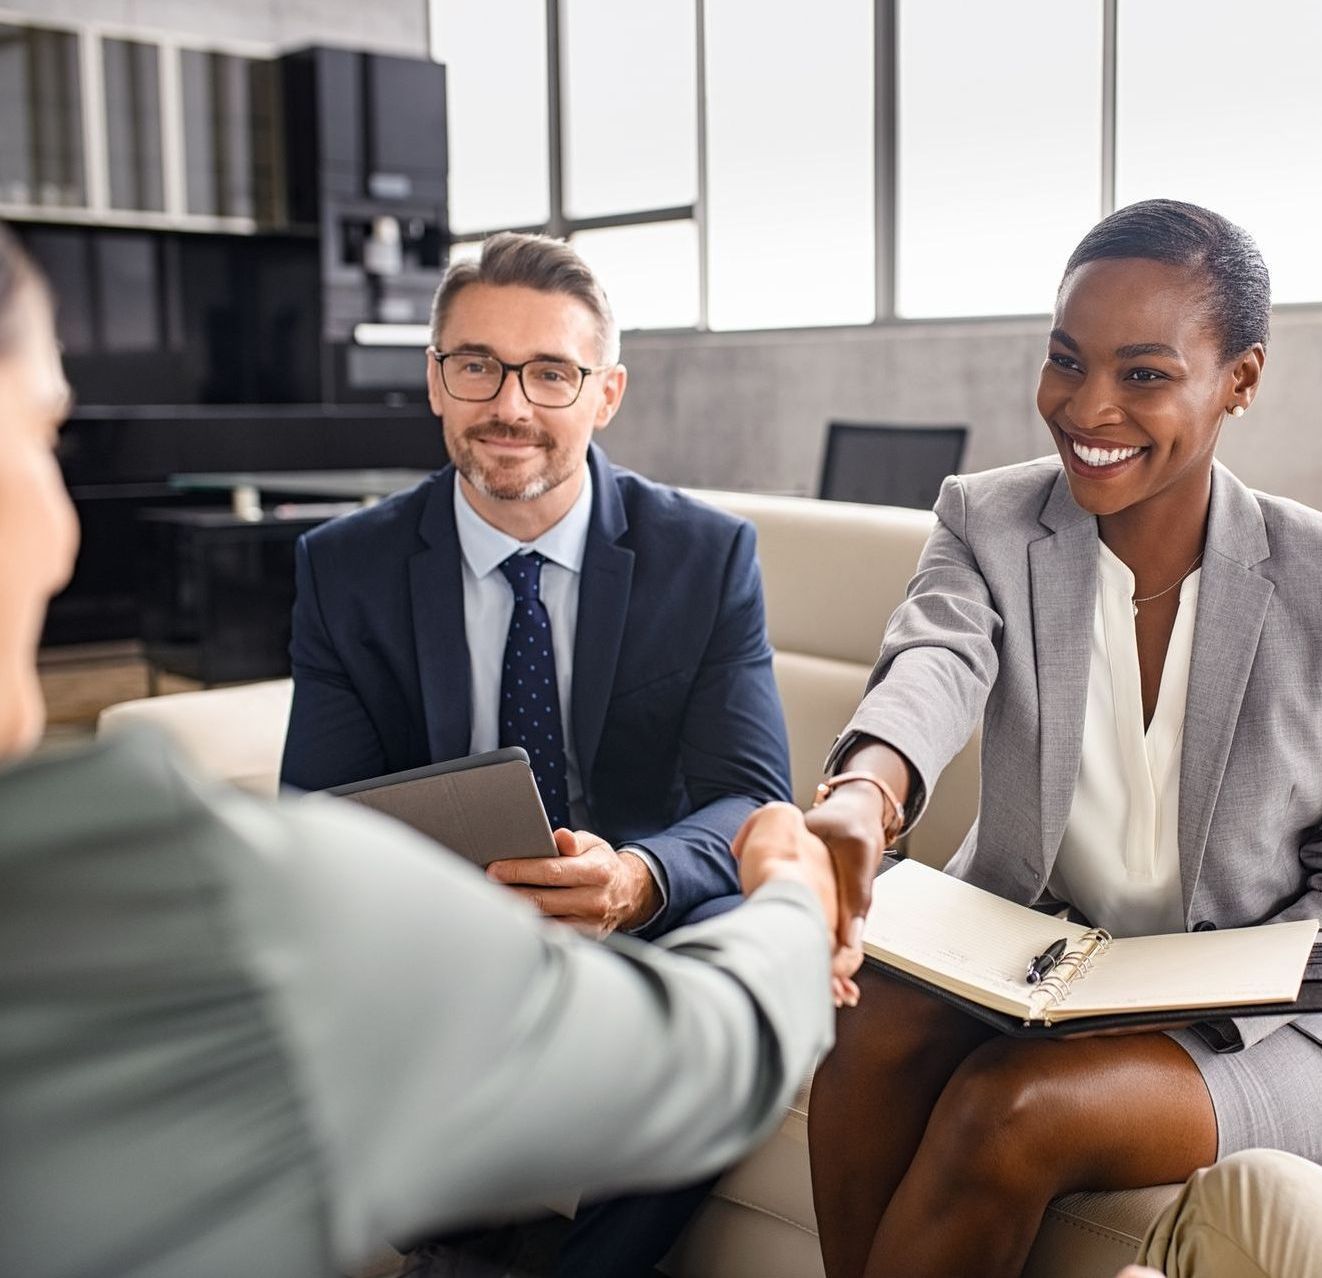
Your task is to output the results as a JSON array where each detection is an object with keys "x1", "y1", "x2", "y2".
[{"x1": 1060, "y1": 200, "x2": 1272, "y2": 359}]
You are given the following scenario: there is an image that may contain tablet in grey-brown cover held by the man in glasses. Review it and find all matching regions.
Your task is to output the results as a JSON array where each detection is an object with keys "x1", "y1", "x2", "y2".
[{"x1": 323, "y1": 745, "x2": 559, "y2": 866}]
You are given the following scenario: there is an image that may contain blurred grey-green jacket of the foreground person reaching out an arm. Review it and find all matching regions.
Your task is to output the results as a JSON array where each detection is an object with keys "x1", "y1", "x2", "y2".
[{"x1": 0, "y1": 735, "x2": 833, "y2": 1278}]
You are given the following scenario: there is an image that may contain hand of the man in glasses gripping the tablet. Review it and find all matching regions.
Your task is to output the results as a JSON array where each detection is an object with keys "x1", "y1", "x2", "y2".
[{"x1": 486, "y1": 830, "x2": 661, "y2": 936}]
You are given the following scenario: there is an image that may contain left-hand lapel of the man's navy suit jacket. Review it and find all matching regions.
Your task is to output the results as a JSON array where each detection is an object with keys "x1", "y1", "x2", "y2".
[{"x1": 408, "y1": 468, "x2": 472, "y2": 761}]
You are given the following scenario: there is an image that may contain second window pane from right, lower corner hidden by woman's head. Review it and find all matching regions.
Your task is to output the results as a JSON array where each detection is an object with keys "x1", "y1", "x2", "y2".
[{"x1": 896, "y1": 0, "x2": 1103, "y2": 316}]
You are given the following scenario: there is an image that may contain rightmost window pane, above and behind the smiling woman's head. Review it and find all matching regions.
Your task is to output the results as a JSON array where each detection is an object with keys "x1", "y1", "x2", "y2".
[{"x1": 1116, "y1": 0, "x2": 1322, "y2": 301}]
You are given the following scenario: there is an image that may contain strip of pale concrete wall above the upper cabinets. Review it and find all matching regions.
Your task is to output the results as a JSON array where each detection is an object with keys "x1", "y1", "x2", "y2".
[{"x1": 0, "y1": 0, "x2": 428, "y2": 57}]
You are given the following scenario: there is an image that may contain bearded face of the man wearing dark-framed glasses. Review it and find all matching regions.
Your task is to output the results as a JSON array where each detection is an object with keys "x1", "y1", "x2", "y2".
[{"x1": 427, "y1": 284, "x2": 625, "y2": 501}]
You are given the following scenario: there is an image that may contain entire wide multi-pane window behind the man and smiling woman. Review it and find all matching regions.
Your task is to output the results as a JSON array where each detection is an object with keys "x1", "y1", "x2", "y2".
[{"x1": 431, "y1": 0, "x2": 1322, "y2": 329}]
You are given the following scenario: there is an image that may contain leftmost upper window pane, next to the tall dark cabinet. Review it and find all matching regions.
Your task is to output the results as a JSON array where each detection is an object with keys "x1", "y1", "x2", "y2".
[{"x1": 432, "y1": 0, "x2": 551, "y2": 234}]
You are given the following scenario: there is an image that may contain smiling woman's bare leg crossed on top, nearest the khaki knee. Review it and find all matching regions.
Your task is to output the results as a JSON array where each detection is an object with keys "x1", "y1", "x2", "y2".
[{"x1": 865, "y1": 1034, "x2": 1216, "y2": 1278}]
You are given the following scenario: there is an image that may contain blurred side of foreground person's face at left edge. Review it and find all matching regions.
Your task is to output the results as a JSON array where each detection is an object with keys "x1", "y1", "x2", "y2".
[{"x1": 0, "y1": 283, "x2": 78, "y2": 759}]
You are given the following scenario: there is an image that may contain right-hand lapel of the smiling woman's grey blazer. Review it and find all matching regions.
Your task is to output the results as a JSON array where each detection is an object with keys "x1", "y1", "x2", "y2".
[{"x1": 1179, "y1": 464, "x2": 1276, "y2": 924}]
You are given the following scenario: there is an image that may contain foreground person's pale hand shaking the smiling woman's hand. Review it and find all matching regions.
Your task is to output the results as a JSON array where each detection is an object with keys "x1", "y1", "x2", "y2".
[{"x1": 731, "y1": 804, "x2": 862, "y2": 1007}]
